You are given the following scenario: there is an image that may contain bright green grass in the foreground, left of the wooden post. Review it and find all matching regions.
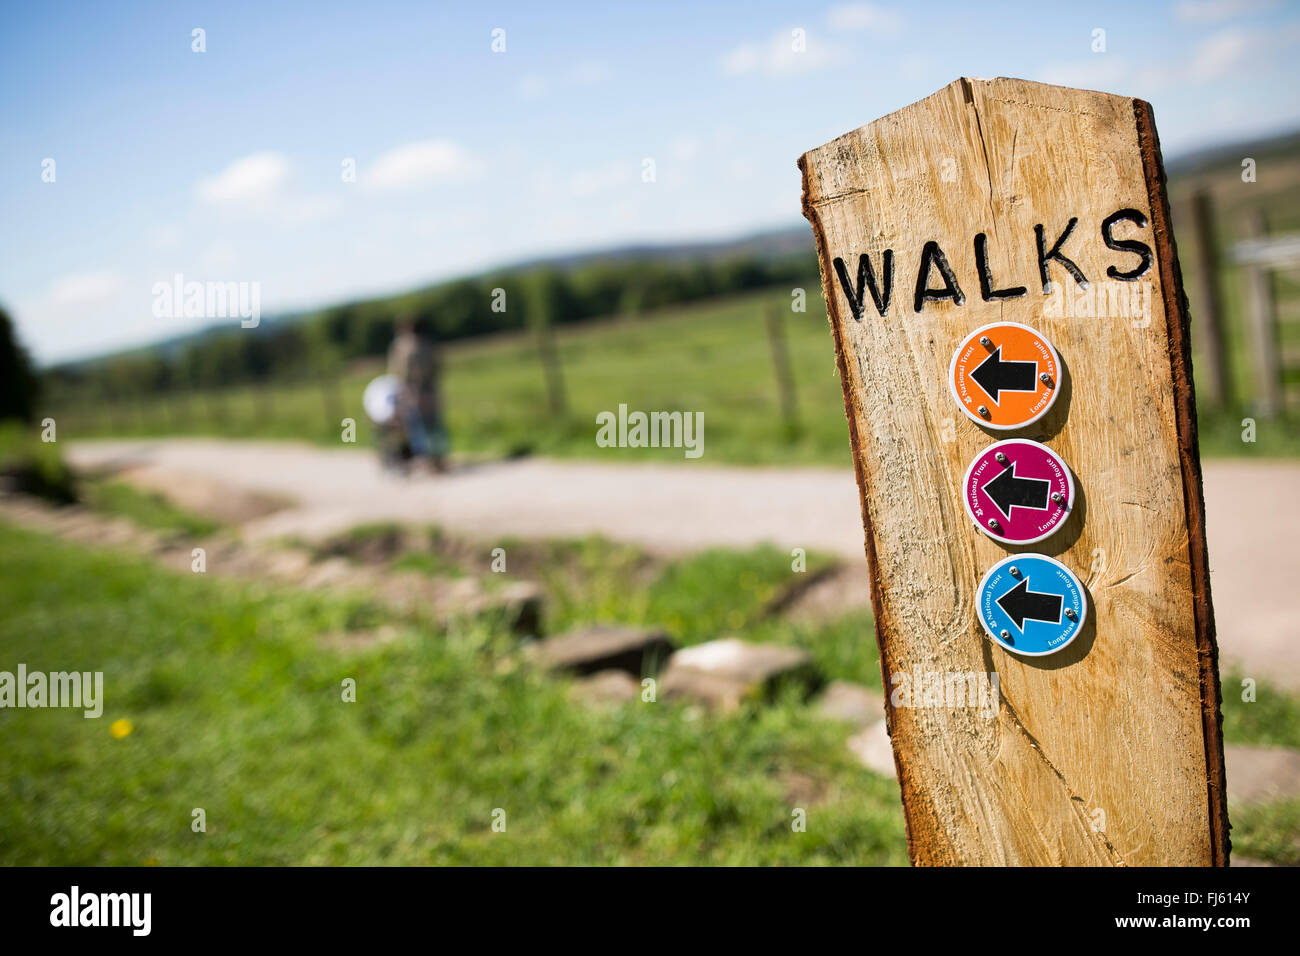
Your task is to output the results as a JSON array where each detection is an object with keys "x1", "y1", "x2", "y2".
[{"x1": 0, "y1": 525, "x2": 906, "y2": 865}]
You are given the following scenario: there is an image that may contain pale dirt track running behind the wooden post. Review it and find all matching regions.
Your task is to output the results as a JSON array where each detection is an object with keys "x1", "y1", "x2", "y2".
[{"x1": 69, "y1": 440, "x2": 1300, "y2": 693}]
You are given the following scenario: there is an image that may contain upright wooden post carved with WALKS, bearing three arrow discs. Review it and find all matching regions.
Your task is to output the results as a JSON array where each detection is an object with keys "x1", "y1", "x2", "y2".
[{"x1": 800, "y1": 79, "x2": 1229, "y2": 866}]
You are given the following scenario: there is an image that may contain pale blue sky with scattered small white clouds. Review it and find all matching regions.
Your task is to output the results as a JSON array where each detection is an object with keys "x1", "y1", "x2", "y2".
[{"x1": 0, "y1": 0, "x2": 1300, "y2": 363}]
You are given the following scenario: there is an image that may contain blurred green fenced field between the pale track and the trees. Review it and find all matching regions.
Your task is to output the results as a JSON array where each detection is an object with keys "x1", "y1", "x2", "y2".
[{"x1": 45, "y1": 287, "x2": 1300, "y2": 467}]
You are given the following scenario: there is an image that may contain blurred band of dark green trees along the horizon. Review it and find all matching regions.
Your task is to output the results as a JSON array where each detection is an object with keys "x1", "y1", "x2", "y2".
[{"x1": 43, "y1": 252, "x2": 816, "y2": 403}]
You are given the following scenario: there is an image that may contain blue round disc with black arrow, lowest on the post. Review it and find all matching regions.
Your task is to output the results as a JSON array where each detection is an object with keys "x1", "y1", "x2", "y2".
[{"x1": 976, "y1": 554, "x2": 1088, "y2": 657}]
